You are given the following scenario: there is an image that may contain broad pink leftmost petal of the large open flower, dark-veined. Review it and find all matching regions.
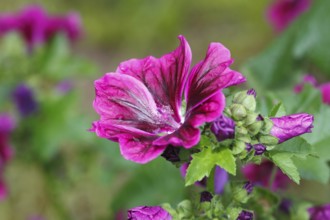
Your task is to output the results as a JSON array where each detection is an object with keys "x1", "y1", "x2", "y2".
[{"x1": 93, "y1": 73, "x2": 160, "y2": 132}]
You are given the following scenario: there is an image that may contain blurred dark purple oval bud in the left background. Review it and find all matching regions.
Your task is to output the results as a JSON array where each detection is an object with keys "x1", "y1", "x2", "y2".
[{"x1": 13, "y1": 84, "x2": 38, "y2": 117}]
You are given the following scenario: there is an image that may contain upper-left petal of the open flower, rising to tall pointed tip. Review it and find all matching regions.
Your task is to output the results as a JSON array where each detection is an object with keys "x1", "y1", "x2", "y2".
[{"x1": 117, "y1": 36, "x2": 191, "y2": 122}]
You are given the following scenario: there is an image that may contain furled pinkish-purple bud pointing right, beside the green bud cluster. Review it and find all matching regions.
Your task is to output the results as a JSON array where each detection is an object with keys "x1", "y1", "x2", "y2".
[{"x1": 270, "y1": 113, "x2": 314, "y2": 143}]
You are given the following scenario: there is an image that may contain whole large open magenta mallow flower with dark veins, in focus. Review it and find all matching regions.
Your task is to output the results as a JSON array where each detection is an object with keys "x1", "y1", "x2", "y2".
[{"x1": 91, "y1": 36, "x2": 245, "y2": 163}]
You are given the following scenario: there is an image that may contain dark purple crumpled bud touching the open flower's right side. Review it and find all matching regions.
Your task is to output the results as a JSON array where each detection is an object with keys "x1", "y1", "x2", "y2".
[{"x1": 211, "y1": 115, "x2": 235, "y2": 141}]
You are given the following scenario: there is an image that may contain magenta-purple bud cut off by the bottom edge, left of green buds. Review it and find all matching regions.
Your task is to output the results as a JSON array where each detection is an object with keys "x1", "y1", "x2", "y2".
[{"x1": 127, "y1": 206, "x2": 172, "y2": 220}]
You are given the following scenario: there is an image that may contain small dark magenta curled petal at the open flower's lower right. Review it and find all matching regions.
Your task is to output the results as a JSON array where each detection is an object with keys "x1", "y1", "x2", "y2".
[{"x1": 153, "y1": 123, "x2": 200, "y2": 148}]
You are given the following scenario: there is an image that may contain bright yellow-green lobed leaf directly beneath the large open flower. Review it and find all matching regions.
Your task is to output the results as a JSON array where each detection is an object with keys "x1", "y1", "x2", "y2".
[{"x1": 186, "y1": 147, "x2": 236, "y2": 186}]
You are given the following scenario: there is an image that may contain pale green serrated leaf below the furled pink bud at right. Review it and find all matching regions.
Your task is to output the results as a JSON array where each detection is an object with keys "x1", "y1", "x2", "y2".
[{"x1": 270, "y1": 152, "x2": 300, "y2": 184}]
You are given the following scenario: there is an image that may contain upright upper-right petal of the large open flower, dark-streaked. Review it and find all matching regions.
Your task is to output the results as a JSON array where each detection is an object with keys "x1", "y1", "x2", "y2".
[{"x1": 185, "y1": 43, "x2": 245, "y2": 112}]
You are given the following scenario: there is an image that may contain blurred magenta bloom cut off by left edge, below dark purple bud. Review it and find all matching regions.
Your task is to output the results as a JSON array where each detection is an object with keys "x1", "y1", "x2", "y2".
[{"x1": 0, "y1": 114, "x2": 15, "y2": 200}]
